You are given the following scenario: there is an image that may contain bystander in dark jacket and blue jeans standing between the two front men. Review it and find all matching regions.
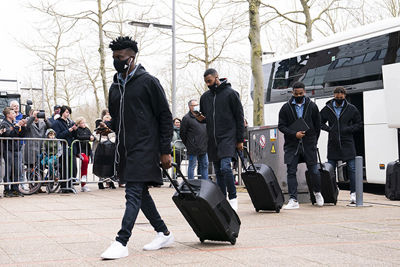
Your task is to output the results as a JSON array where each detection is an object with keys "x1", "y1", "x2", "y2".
[{"x1": 181, "y1": 99, "x2": 208, "y2": 179}]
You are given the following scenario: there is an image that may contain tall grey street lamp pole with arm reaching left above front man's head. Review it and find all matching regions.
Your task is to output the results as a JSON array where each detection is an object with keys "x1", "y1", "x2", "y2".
[{"x1": 128, "y1": 0, "x2": 176, "y2": 117}]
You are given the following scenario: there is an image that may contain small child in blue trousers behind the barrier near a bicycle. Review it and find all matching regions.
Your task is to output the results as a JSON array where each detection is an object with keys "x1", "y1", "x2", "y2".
[{"x1": 42, "y1": 128, "x2": 62, "y2": 180}]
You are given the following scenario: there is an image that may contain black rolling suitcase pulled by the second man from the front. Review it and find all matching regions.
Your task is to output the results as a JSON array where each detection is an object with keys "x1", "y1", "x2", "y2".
[{"x1": 242, "y1": 149, "x2": 285, "y2": 212}]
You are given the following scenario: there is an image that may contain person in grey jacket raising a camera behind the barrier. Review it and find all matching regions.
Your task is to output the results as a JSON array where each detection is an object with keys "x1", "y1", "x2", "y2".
[{"x1": 24, "y1": 109, "x2": 51, "y2": 171}]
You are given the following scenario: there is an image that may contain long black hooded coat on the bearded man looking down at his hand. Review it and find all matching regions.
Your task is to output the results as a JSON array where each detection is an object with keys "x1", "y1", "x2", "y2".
[{"x1": 200, "y1": 79, "x2": 244, "y2": 161}]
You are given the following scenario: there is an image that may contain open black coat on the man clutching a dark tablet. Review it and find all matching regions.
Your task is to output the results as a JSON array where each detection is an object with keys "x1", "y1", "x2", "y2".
[{"x1": 278, "y1": 97, "x2": 321, "y2": 165}]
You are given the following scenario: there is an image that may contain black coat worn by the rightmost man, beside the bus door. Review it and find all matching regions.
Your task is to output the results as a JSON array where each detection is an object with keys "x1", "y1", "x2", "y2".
[{"x1": 321, "y1": 100, "x2": 363, "y2": 161}]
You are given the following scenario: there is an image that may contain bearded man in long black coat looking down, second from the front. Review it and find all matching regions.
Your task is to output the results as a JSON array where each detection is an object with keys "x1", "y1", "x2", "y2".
[{"x1": 196, "y1": 69, "x2": 244, "y2": 214}]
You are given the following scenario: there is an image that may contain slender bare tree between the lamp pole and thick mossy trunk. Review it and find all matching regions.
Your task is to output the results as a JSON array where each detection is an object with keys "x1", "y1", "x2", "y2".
[{"x1": 177, "y1": 0, "x2": 243, "y2": 92}]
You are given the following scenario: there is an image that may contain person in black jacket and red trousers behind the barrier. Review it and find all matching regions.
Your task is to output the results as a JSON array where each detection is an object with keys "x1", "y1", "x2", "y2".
[{"x1": 75, "y1": 117, "x2": 96, "y2": 192}]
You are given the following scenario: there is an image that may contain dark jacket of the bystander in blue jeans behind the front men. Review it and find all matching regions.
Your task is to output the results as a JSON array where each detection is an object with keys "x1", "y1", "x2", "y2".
[{"x1": 180, "y1": 111, "x2": 207, "y2": 156}]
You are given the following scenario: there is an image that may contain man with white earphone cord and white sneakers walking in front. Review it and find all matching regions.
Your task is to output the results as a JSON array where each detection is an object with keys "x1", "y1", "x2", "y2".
[{"x1": 101, "y1": 37, "x2": 174, "y2": 259}]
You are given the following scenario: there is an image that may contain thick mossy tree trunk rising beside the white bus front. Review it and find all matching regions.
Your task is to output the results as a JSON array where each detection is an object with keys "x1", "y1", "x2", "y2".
[{"x1": 248, "y1": 0, "x2": 264, "y2": 126}]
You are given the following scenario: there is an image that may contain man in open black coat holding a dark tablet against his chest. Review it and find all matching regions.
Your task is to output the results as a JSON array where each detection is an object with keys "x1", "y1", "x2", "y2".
[{"x1": 278, "y1": 82, "x2": 324, "y2": 210}]
